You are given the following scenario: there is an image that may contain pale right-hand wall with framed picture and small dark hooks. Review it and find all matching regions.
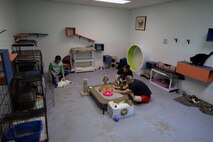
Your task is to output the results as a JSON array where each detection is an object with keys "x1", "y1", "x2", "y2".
[{"x1": 130, "y1": 0, "x2": 213, "y2": 103}]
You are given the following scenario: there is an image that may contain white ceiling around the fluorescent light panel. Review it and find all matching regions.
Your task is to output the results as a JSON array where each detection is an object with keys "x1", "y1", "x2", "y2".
[{"x1": 46, "y1": 0, "x2": 176, "y2": 9}]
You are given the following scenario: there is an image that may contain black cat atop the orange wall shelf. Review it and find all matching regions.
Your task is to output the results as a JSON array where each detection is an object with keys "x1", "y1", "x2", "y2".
[{"x1": 190, "y1": 51, "x2": 213, "y2": 66}]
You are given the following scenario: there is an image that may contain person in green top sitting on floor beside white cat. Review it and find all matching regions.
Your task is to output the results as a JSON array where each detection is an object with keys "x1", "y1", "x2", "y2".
[{"x1": 49, "y1": 55, "x2": 68, "y2": 87}]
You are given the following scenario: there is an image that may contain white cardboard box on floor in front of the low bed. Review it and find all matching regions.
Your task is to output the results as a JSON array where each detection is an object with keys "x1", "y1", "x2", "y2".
[{"x1": 107, "y1": 99, "x2": 134, "y2": 119}]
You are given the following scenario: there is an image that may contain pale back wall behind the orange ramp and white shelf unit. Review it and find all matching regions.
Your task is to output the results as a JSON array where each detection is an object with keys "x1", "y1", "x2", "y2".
[{"x1": 17, "y1": 0, "x2": 130, "y2": 71}]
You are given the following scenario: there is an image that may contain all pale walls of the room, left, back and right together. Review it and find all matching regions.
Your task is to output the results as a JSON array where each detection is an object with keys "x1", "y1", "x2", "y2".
[{"x1": 0, "y1": 0, "x2": 213, "y2": 104}]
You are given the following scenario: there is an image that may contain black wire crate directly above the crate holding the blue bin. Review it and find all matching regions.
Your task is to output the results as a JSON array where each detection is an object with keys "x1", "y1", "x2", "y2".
[{"x1": 11, "y1": 79, "x2": 46, "y2": 111}]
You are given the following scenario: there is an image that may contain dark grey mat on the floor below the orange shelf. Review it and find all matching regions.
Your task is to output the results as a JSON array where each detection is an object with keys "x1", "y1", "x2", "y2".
[{"x1": 174, "y1": 95, "x2": 213, "y2": 115}]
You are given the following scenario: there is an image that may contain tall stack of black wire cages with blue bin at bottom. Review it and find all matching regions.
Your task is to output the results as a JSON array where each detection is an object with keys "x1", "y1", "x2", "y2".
[{"x1": 1, "y1": 49, "x2": 48, "y2": 142}]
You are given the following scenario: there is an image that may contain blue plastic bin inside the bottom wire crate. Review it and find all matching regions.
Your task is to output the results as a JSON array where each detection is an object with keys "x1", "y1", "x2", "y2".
[{"x1": 7, "y1": 120, "x2": 43, "y2": 142}]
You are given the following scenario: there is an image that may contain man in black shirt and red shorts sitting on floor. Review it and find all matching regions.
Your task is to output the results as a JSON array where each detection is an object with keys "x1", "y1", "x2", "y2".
[{"x1": 114, "y1": 75, "x2": 152, "y2": 103}]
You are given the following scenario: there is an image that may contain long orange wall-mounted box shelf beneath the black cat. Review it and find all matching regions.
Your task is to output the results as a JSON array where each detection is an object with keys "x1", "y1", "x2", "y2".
[{"x1": 176, "y1": 61, "x2": 213, "y2": 83}]
